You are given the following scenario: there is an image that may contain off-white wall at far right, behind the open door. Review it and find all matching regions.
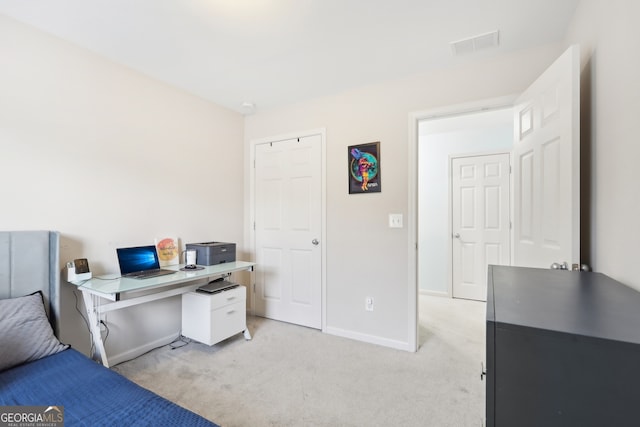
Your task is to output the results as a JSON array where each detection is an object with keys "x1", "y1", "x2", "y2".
[{"x1": 566, "y1": 0, "x2": 640, "y2": 290}]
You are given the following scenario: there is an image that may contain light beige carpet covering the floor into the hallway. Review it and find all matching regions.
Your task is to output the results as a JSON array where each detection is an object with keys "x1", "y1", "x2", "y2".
[{"x1": 114, "y1": 296, "x2": 485, "y2": 427}]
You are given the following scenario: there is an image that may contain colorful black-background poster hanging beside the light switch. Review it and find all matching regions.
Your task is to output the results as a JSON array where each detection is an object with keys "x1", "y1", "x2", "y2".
[{"x1": 347, "y1": 142, "x2": 382, "y2": 194}]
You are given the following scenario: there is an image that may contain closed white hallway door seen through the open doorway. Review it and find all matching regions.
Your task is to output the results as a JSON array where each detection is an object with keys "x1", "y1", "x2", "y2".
[{"x1": 451, "y1": 153, "x2": 511, "y2": 301}]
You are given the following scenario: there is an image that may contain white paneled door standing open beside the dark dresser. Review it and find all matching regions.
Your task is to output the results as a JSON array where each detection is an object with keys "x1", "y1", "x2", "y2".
[{"x1": 513, "y1": 46, "x2": 580, "y2": 268}]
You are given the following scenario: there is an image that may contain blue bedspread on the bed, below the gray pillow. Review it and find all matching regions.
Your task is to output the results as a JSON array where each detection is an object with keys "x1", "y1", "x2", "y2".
[{"x1": 0, "y1": 349, "x2": 216, "y2": 427}]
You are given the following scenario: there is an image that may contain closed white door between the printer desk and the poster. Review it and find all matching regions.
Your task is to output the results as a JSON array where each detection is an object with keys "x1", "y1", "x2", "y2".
[{"x1": 254, "y1": 135, "x2": 323, "y2": 329}]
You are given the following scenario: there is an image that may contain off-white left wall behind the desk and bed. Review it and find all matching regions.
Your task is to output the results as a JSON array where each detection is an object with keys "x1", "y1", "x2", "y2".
[{"x1": 0, "y1": 15, "x2": 244, "y2": 362}]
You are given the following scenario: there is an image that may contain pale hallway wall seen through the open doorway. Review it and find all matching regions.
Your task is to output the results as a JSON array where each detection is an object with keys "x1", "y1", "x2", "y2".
[{"x1": 418, "y1": 108, "x2": 513, "y2": 295}]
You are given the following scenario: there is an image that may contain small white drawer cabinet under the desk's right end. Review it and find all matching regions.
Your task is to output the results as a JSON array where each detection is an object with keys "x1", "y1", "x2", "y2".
[{"x1": 182, "y1": 286, "x2": 251, "y2": 345}]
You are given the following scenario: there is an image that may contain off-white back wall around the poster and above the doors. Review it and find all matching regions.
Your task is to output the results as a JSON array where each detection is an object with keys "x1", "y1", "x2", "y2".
[{"x1": 245, "y1": 45, "x2": 561, "y2": 348}]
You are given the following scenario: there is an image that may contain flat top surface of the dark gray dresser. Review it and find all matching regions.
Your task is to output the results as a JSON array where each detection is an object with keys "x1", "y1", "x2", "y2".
[{"x1": 487, "y1": 266, "x2": 640, "y2": 344}]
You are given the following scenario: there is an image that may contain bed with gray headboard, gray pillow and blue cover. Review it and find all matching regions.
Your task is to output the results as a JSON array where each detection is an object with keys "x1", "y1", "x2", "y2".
[{"x1": 0, "y1": 231, "x2": 216, "y2": 426}]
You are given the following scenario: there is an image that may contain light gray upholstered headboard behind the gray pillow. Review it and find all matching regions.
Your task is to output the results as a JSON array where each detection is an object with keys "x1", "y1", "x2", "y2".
[{"x1": 0, "y1": 231, "x2": 60, "y2": 336}]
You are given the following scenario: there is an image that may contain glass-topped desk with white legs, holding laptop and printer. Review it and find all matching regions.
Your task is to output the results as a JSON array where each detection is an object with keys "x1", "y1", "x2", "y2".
[{"x1": 72, "y1": 261, "x2": 255, "y2": 367}]
